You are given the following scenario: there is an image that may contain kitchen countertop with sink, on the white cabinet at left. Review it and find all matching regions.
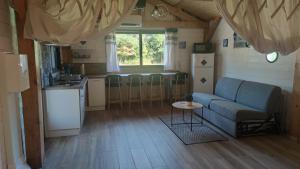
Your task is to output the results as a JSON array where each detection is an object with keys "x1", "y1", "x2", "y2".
[{"x1": 44, "y1": 77, "x2": 88, "y2": 90}]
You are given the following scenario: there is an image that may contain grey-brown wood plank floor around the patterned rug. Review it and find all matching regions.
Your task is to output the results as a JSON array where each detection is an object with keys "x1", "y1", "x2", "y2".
[{"x1": 44, "y1": 105, "x2": 300, "y2": 169}]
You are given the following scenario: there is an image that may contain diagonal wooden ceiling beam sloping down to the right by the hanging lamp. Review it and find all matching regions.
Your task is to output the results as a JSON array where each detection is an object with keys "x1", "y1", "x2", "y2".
[{"x1": 148, "y1": 0, "x2": 208, "y2": 27}]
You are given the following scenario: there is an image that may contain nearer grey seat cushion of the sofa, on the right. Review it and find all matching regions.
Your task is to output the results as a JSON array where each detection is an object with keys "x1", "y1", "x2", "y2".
[{"x1": 210, "y1": 100, "x2": 268, "y2": 122}]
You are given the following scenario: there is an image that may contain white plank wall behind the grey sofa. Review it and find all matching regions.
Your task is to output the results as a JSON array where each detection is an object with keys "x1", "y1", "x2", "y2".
[{"x1": 212, "y1": 19, "x2": 296, "y2": 92}]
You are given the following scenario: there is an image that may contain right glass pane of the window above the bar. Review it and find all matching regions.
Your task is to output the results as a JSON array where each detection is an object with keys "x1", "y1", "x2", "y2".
[{"x1": 142, "y1": 34, "x2": 165, "y2": 65}]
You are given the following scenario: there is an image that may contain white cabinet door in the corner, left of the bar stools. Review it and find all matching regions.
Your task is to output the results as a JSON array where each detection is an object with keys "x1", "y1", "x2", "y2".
[{"x1": 88, "y1": 78, "x2": 105, "y2": 108}]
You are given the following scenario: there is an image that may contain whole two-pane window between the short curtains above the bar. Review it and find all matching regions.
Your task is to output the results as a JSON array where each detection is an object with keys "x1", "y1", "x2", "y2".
[{"x1": 116, "y1": 31, "x2": 165, "y2": 66}]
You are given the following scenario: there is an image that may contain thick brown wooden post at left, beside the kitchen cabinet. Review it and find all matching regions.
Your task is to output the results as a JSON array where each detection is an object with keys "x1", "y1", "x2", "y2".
[{"x1": 14, "y1": 0, "x2": 44, "y2": 169}]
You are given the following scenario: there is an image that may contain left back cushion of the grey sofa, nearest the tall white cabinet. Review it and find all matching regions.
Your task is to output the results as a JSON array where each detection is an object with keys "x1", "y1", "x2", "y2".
[{"x1": 215, "y1": 77, "x2": 243, "y2": 101}]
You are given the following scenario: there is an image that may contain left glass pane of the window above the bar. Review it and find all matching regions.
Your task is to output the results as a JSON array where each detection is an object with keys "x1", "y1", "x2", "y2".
[{"x1": 116, "y1": 34, "x2": 140, "y2": 66}]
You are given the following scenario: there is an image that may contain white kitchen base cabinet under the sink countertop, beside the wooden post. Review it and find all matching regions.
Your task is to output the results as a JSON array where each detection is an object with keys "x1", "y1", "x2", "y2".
[{"x1": 44, "y1": 79, "x2": 86, "y2": 137}]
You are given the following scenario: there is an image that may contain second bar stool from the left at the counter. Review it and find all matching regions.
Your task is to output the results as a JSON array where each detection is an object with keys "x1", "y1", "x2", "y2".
[{"x1": 127, "y1": 75, "x2": 143, "y2": 109}]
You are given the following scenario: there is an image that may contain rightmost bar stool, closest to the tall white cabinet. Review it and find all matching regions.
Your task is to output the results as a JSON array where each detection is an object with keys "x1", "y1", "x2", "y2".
[{"x1": 172, "y1": 72, "x2": 188, "y2": 101}]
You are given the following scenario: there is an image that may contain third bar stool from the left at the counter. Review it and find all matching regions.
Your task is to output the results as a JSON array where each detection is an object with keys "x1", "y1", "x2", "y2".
[{"x1": 148, "y1": 74, "x2": 164, "y2": 106}]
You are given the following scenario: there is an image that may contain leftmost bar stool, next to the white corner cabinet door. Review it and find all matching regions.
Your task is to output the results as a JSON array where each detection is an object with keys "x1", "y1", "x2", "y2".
[{"x1": 106, "y1": 75, "x2": 123, "y2": 109}]
